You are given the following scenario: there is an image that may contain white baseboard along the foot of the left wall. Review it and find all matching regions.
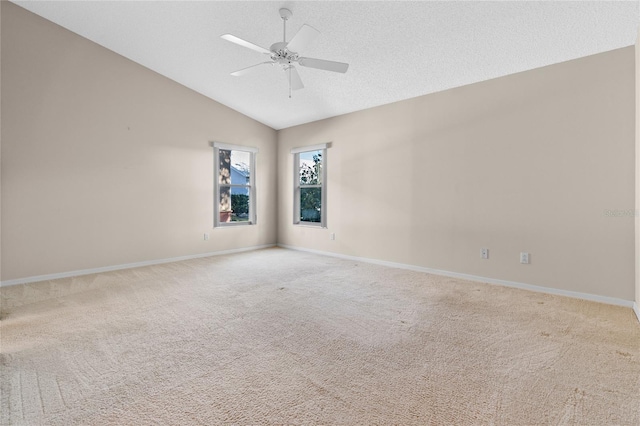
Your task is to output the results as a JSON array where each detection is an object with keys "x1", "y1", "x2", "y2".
[{"x1": 0, "y1": 244, "x2": 275, "y2": 287}]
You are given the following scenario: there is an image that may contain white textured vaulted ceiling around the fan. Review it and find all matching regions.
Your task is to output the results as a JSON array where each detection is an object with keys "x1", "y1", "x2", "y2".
[{"x1": 14, "y1": 0, "x2": 640, "y2": 129}]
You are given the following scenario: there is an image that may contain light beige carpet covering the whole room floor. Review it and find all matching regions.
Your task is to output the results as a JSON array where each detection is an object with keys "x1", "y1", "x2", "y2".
[{"x1": 0, "y1": 249, "x2": 640, "y2": 425}]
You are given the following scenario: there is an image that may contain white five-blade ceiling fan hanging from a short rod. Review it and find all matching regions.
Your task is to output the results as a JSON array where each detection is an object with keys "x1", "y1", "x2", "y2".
[{"x1": 220, "y1": 8, "x2": 349, "y2": 97}]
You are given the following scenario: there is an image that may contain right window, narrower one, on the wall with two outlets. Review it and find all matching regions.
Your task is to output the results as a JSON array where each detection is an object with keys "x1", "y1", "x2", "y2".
[{"x1": 291, "y1": 144, "x2": 327, "y2": 228}]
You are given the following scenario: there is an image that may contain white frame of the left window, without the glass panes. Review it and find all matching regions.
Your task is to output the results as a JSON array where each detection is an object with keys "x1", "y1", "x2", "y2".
[{"x1": 211, "y1": 142, "x2": 258, "y2": 228}]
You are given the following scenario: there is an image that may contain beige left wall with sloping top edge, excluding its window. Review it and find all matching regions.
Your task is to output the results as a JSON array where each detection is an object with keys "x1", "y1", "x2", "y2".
[{"x1": 1, "y1": 2, "x2": 277, "y2": 280}]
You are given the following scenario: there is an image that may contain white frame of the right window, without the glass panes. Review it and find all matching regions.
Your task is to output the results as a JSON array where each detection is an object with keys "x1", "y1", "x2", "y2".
[{"x1": 291, "y1": 143, "x2": 329, "y2": 228}]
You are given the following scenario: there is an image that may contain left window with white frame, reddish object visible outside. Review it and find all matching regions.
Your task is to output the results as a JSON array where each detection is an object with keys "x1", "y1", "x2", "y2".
[{"x1": 213, "y1": 142, "x2": 258, "y2": 226}]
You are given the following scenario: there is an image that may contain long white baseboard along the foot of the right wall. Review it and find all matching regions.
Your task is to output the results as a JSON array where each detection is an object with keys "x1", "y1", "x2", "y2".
[{"x1": 278, "y1": 244, "x2": 640, "y2": 312}]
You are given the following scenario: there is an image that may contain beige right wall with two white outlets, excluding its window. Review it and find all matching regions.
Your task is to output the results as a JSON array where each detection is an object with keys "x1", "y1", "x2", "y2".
[{"x1": 278, "y1": 47, "x2": 635, "y2": 301}]
